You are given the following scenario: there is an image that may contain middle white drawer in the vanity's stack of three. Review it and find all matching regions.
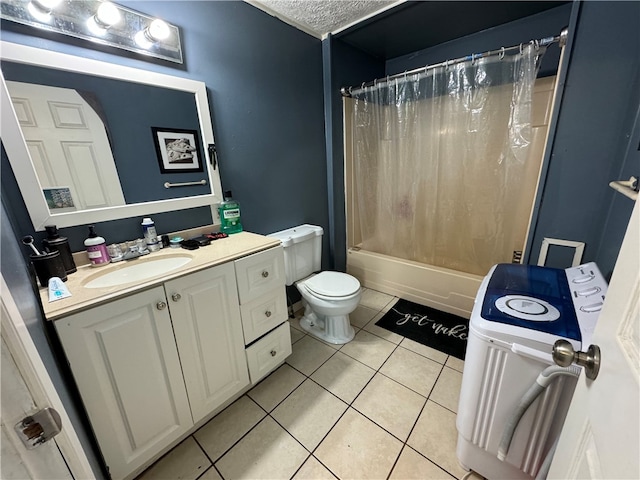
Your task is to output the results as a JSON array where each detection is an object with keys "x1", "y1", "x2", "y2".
[{"x1": 240, "y1": 287, "x2": 288, "y2": 345}]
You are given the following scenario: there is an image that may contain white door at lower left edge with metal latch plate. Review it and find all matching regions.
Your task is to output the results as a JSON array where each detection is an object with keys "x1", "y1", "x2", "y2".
[{"x1": 0, "y1": 334, "x2": 73, "y2": 480}]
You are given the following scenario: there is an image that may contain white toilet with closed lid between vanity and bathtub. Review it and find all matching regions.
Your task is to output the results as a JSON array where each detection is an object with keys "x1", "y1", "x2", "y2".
[{"x1": 269, "y1": 225, "x2": 362, "y2": 345}]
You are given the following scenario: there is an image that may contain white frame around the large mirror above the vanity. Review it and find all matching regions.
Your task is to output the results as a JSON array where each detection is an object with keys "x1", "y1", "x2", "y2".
[{"x1": 0, "y1": 41, "x2": 223, "y2": 231}]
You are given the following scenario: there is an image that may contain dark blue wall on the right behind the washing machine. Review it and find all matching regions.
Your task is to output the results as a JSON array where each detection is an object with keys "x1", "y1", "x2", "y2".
[{"x1": 531, "y1": 2, "x2": 640, "y2": 277}]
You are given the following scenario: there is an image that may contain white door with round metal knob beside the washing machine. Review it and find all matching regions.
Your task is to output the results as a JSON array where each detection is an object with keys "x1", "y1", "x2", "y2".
[{"x1": 548, "y1": 197, "x2": 640, "y2": 479}]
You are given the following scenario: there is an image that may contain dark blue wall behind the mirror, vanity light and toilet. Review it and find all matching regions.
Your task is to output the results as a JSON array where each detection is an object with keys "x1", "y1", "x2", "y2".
[{"x1": 2, "y1": 0, "x2": 328, "y2": 257}]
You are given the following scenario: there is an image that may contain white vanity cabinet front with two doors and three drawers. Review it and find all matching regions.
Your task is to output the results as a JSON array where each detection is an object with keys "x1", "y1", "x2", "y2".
[{"x1": 54, "y1": 246, "x2": 291, "y2": 479}]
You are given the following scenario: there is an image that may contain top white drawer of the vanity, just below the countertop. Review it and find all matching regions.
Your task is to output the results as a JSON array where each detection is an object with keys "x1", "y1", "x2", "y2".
[{"x1": 235, "y1": 247, "x2": 285, "y2": 304}]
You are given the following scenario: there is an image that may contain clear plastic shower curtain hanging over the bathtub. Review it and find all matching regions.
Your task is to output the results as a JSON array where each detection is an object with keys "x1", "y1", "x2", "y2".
[{"x1": 352, "y1": 45, "x2": 544, "y2": 275}]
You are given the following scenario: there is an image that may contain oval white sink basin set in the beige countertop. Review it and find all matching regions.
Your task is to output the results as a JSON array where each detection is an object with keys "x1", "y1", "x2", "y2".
[{"x1": 84, "y1": 255, "x2": 193, "y2": 288}]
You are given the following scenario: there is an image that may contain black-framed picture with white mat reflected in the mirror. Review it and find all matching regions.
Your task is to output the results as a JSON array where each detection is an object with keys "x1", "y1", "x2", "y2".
[{"x1": 151, "y1": 127, "x2": 204, "y2": 173}]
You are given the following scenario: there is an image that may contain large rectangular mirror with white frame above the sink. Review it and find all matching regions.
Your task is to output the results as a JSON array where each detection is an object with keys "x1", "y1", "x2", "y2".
[{"x1": 0, "y1": 42, "x2": 222, "y2": 231}]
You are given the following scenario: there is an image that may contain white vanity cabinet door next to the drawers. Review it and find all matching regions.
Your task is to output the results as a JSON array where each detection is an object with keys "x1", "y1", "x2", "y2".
[{"x1": 165, "y1": 263, "x2": 249, "y2": 423}]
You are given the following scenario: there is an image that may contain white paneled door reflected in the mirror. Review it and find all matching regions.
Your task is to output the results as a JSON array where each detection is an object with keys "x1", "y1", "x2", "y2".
[{"x1": 7, "y1": 81, "x2": 125, "y2": 213}]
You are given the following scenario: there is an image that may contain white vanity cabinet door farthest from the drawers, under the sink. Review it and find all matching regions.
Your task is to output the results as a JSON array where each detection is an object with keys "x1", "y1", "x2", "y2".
[{"x1": 55, "y1": 287, "x2": 193, "y2": 479}]
